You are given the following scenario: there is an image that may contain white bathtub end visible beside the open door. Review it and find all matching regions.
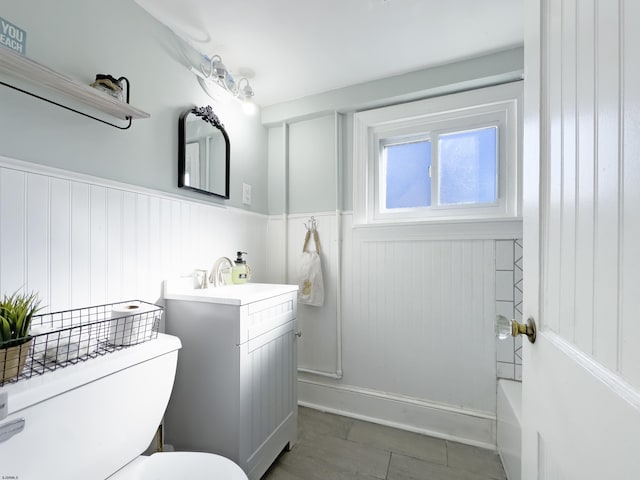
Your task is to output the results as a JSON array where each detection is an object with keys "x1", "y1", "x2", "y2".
[{"x1": 497, "y1": 380, "x2": 522, "y2": 480}]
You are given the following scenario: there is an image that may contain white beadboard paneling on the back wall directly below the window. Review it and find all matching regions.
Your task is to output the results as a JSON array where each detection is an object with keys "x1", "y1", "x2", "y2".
[{"x1": 344, "y1": 234, "x2": 496, "y2": 414}]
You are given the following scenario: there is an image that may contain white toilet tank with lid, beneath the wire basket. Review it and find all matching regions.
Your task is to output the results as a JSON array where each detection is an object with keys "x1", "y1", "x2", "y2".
[{"x1": 0, "y1": 334, "x2": 181, "y2": 480}]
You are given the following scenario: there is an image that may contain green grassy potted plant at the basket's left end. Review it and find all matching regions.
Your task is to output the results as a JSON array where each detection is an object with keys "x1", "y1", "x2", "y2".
[{"x1": 0, "y1": 292, "x2": 40, "y2": 385}]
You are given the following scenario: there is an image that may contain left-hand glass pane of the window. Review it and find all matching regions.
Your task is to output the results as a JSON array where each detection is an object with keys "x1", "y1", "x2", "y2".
[{"x1": 384, "y1": 141, "x2": 431, "y2": 208}]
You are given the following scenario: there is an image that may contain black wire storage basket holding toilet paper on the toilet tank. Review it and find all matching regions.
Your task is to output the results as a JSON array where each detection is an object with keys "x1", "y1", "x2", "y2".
[{"x1": 0, "y1": 300, "x2": 164, "y2": 386}]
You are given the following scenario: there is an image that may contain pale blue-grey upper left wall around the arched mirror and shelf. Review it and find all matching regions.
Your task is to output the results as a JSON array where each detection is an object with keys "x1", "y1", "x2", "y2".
[{"x1": 0, "y1": 0, "x2": 267, "y2": 213}]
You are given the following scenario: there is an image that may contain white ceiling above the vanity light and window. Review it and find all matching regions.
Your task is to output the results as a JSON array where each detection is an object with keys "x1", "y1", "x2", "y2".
[{"x1": 135, "y1": 0, "x2": 524, "y2": 106}]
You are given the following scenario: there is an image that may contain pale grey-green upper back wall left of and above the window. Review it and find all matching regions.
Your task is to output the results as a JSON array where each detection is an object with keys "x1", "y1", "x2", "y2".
[{"x1": 262, "y1": 48, "x2": 524, "y2": 214}]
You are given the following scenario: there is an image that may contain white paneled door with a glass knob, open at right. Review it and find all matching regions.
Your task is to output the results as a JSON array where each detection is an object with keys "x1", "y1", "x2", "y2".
[{"x1": 522, "y1": 0, "x2": 640, "y2": 480}]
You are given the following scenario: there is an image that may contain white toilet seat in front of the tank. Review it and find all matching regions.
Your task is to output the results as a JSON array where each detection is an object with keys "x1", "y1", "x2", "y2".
[{"x1": 109, "y1": 452, "x2": 248, "y2": 480}]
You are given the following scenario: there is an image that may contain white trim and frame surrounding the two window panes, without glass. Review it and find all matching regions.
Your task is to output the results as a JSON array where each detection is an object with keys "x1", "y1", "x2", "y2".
[{"x1": 353, "y1": 82, "x2": 523, "y2": 226}]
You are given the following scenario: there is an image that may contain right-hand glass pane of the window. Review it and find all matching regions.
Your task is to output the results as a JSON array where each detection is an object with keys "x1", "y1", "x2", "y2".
[{"x1": 438, "y1": 127, "x2": 498, "y2": 205}]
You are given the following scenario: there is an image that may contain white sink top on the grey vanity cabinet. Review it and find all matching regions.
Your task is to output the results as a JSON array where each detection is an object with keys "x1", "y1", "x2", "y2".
[{"x1": 164, "y1": 277, "x2": 298, "y2": 305}]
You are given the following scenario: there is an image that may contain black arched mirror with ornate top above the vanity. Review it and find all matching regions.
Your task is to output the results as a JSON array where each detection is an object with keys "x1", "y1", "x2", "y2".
[{"x1": 178, "y1": 106, "x2": 230, "y2": 198}]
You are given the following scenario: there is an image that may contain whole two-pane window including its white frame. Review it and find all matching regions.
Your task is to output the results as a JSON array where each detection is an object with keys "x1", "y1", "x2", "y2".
[{"x1": 354, "y1": 82, "x2": 522, "y2": 224}]
